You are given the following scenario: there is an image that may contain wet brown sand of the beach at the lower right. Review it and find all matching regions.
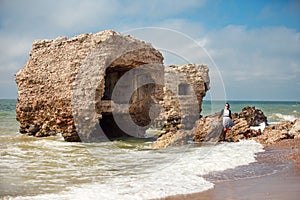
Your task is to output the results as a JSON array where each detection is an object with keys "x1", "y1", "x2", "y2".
[{"x1": 164, "y1": 139, "x2": 300, "y2": 200}]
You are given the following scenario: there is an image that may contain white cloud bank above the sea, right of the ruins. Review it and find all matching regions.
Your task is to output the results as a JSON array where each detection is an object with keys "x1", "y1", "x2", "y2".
[{"x1": 132, "y1": 19, "x2": 300, "y2": 100}]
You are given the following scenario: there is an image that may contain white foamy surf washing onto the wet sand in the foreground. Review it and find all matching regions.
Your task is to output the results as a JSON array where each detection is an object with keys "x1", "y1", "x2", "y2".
[{"x1": 10, "y1": 140, "x2": 263, "y2": 200}]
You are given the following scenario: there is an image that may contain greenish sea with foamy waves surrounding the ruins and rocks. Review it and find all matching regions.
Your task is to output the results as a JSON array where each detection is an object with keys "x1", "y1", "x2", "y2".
[{"x1": 0, "y1": 100, "x2": 300, "y2": 200}]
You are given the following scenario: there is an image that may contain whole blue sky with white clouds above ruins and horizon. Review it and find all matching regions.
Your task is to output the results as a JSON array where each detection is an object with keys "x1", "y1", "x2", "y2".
[{"x1": 0, "y1": 0, "x2": 300, "y2": 101}]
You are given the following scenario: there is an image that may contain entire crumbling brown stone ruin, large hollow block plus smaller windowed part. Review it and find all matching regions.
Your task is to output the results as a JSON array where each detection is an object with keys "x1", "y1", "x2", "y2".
[{"x1": 16, "y1": 31, "x2": 209, "y2": 141}]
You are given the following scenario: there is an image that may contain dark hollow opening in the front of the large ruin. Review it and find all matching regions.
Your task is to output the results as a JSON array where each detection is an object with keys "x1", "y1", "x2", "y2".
[{"x1": 97, "y1": 66, "x2": 162, "y2": 140}]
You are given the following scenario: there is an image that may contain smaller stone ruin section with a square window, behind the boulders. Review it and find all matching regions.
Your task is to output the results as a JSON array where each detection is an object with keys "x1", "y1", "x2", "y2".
[{"x1": 157, "y1": 64, "x2": 210, "y2": 129}]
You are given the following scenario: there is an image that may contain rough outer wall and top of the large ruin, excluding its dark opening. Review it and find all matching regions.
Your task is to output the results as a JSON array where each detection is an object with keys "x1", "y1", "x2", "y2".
[{"x1": 16, "y1": 31, "x2": 163, "y2": 141}]
